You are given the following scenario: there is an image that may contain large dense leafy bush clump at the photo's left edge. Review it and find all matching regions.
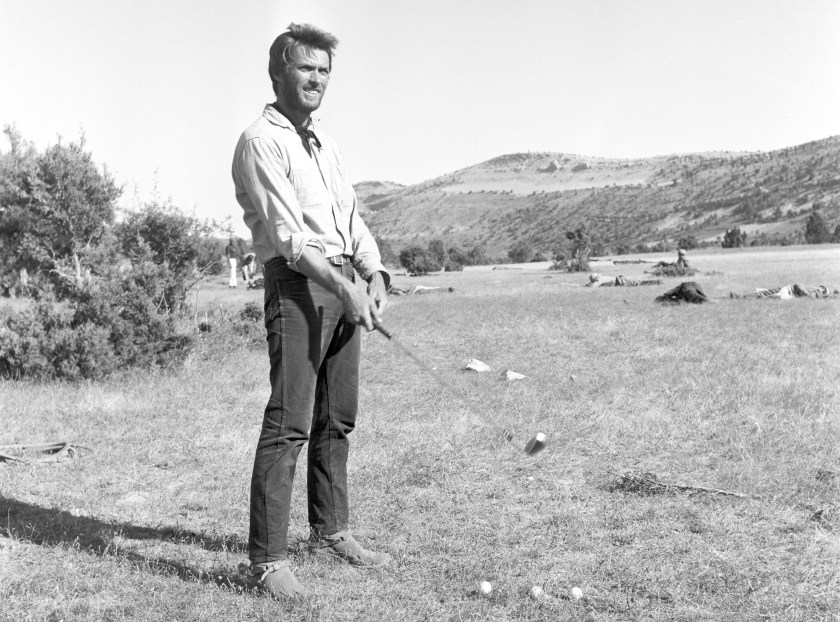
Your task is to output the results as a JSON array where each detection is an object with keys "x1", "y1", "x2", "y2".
[{"x1": 0, "y1": 128, "x2": 204, "y2": 380}]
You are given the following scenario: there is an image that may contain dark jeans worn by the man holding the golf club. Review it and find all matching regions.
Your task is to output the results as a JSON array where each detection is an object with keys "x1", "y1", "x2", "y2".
[{"x1": 248, "y1": 260, "x2": 361, "y2": 564}]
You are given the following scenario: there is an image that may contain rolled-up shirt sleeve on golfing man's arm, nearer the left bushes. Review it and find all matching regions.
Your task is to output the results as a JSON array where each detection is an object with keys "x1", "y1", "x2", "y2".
[{"x1": 233, "y1": 138, "x2": 325, "y2": 265}]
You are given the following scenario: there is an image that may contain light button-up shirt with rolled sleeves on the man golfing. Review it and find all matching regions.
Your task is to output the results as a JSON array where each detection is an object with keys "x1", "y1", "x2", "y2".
[{"x1": 232, "y1": 104, "x2": 390, "y2": 283}]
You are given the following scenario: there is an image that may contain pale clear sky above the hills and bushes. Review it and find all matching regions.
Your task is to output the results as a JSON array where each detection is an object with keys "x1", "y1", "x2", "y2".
[{"x1": 0, "y1": 0, "x2": 840, "y2": 233}]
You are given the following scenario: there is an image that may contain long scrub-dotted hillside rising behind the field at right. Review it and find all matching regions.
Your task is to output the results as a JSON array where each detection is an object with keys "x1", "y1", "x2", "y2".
[{"x1": 356, "y1": 136, "x2": 840, "y2": 256}]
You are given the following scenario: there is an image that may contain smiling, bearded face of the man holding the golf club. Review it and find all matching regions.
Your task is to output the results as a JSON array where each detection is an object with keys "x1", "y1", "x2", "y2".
[{"x1": 275, "y1": 45, "x2": 330, "y2": 124}]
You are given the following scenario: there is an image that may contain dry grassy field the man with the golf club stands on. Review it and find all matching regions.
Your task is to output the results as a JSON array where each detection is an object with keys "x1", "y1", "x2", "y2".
[{"x1": 0, "y1": 246, "x2": 840, "y2": 622}]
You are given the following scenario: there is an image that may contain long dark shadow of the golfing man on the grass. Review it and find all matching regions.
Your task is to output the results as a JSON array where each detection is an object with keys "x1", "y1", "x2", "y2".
[{"x1": 0, "y1": 496, "x2": 253, "y2": 590}]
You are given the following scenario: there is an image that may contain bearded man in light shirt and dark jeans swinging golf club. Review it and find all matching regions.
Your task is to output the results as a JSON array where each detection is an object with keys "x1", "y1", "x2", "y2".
[{"x1": 233, "y1": 24, "x2": 390, "y2": 597}]
